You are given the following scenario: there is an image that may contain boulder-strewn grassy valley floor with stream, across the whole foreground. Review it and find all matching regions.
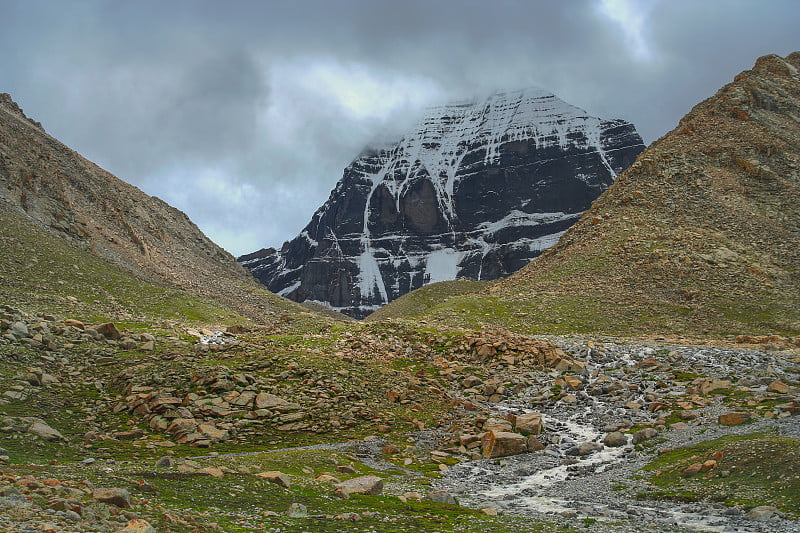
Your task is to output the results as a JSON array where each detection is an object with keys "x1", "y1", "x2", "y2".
[{"x1": 0, "y1": 306, "x2": 800, "y2": 533}]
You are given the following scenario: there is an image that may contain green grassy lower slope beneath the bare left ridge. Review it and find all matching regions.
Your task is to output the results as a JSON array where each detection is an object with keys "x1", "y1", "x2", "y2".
[{"x1": 0, "y1": 202, "x2": 302, "y2": 324}]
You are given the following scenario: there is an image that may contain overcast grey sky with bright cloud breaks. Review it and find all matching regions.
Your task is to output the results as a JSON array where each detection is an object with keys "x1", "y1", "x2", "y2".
[{"x1": 0, "y1": 0, "x2": 800, "y2": 255}]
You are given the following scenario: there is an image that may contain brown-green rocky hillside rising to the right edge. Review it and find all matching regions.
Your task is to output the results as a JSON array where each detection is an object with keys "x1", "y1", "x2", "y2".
[{"x1": 384, "y1": 52, "x2": 800, "y2": 334}]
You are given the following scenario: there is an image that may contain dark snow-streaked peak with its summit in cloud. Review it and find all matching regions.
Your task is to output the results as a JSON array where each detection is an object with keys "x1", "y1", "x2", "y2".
[{"x1": 239, "y1": 89, "x2": 644, "y2": 318}]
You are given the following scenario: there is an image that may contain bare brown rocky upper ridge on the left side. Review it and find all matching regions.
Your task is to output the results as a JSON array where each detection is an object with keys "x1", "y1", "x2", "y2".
[{"x1": 0, "y1": 93, "x2": 301, "y2": 319}]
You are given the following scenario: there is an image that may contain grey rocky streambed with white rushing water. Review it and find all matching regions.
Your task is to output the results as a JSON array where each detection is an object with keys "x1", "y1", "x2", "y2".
[{"x1": 436, "y1": 339, "x2": 800, "y2": 533}]
